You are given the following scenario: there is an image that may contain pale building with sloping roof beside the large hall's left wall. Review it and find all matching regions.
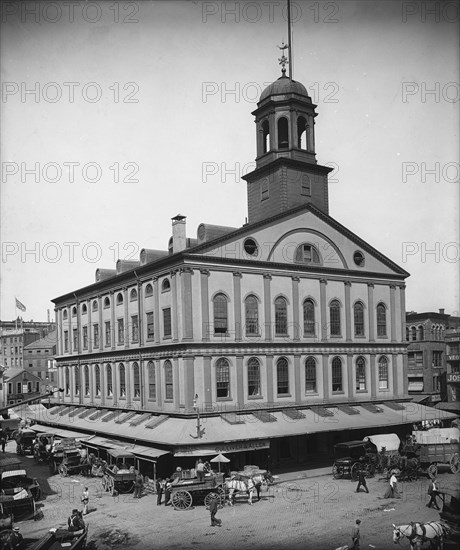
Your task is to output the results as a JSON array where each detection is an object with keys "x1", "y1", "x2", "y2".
[{"x1": 24, "y1": 331, "x2": 57, "y2": 393}]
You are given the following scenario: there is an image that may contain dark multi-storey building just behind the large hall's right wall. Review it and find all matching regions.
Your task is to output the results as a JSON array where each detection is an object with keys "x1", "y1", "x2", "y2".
[{"x1": 406, "y1": 309, "x2": 458, "y2": 405}]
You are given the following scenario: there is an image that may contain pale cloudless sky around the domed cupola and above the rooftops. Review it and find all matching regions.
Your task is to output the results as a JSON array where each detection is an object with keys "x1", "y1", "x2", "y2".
[{"x1": 0, "y1": 0, "x2": 460, "y2": 321}]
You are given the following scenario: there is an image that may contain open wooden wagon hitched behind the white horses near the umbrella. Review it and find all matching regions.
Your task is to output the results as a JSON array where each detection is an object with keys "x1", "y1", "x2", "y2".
[{"x1": 171, "y1": 470, "x2": 225, "y2": 510}]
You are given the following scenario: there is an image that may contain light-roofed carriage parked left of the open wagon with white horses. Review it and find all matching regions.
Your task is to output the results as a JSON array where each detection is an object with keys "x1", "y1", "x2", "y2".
[{"x1": 101, "y1": 449, "x2": 136, "y2": 496}]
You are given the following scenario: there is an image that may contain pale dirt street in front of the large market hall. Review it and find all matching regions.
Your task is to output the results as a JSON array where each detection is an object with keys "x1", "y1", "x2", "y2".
[{"x1": 4, "y1": 442, "x2": 455, "y2": 550}]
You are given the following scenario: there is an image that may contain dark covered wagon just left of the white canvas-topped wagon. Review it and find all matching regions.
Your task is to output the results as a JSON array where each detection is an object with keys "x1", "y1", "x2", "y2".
[{"x1": 332, "y1": 440, "x2": 376, "y2": 481}]
